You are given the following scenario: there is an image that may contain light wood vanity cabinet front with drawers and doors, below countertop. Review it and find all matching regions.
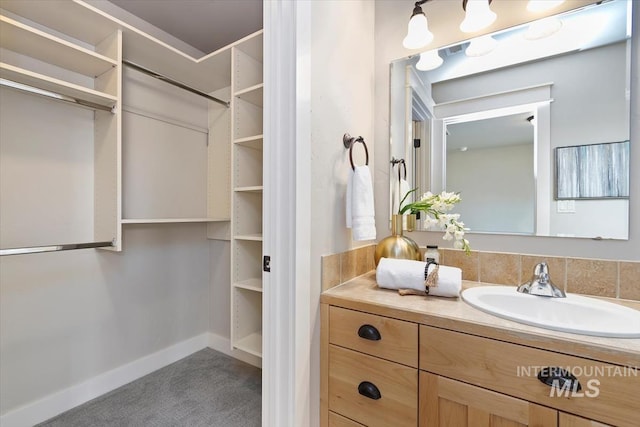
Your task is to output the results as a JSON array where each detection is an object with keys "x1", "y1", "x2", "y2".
[{"x1": 321, "y1": 300, "x2": 640, "y2": 427}]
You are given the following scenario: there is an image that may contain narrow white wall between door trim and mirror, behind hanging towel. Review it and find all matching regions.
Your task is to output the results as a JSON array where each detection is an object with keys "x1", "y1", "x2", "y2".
[{"x1": 300, "y1": 0, "x2": 376, "y2": 425}]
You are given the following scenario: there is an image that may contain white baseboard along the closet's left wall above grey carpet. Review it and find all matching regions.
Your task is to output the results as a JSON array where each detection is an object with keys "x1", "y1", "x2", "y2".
[{"x1": 0, "y1": 333, "x2": 209, "y2": 427}]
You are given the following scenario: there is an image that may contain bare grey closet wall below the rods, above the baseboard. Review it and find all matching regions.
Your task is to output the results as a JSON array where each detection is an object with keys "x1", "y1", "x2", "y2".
[{"x1": 0, "y1": 224, "x2": 210, "y2": 415}]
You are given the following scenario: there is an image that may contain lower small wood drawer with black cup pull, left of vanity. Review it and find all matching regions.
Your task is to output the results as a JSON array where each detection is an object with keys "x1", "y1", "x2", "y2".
[{"x1": 329, "y1": 345, "x2": 418, "y2": 427}]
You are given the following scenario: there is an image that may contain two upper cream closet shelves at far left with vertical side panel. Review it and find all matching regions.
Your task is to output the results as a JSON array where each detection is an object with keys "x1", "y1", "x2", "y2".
[{"x1": 0, "y1": 9, "x2": 122, "y2": 253}]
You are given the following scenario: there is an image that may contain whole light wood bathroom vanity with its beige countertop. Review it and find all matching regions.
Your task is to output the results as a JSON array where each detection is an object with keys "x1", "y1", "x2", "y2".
[{"x1": 321, "y1": 271, "x2": 640, "y2": 427}]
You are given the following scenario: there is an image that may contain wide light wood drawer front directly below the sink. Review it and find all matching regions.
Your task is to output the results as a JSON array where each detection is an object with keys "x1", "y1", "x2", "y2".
[{"x1": 420, "y1": 326, "x2": 640, "y2": 426}]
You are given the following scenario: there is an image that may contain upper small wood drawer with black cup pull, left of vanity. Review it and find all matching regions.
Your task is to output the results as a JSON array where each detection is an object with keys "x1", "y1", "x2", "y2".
[{"x1": 329, "y1": 307, "x2": 418, "y2": 368}]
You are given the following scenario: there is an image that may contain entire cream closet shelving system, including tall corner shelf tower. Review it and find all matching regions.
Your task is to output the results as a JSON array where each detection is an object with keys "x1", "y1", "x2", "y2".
[{"x1": 0, "y1": 0, "x2": 263, "y2": 364}]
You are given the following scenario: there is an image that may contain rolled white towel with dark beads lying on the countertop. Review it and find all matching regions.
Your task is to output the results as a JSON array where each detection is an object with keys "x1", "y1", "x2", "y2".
[{"x1": 376, "y1": 258, "x2": 462, "y2": 297}]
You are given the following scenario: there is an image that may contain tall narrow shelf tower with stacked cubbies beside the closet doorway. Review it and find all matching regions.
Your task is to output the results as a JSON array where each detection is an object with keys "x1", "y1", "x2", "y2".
[{"x1": 231, "y1": 32, "x2": 263, "y2": 357}]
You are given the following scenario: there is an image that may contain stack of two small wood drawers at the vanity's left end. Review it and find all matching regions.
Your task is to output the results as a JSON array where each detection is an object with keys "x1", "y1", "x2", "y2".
[{"x1": 328, "y1": 307, "x2": 418, "y2": 427}]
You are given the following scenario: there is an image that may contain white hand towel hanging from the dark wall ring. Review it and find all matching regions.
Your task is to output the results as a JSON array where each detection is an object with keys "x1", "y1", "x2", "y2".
[{"x1": 346, "y1": 165, "x2": 376, "y2": 241}]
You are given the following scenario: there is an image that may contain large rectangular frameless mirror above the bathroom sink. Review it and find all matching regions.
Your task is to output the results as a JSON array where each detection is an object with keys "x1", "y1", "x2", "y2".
[{"x1": 390, "y1": 0, "x2": 633, "y2": 239}]
